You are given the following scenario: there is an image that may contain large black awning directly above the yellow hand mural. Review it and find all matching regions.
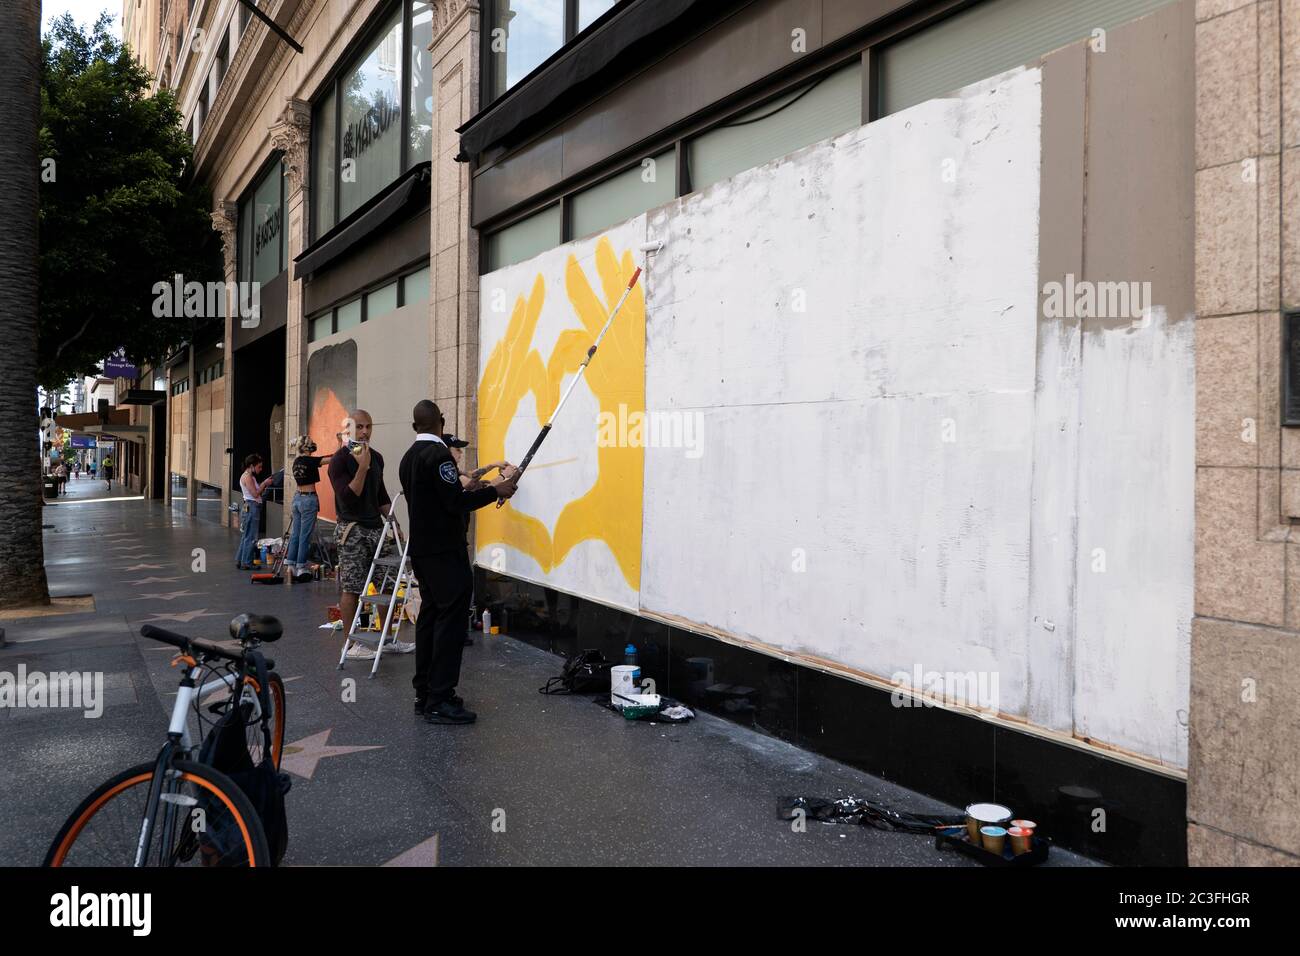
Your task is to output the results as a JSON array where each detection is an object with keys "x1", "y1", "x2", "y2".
[{"x1": 456, "y1": 0, "x2": 751, "y2": 163}]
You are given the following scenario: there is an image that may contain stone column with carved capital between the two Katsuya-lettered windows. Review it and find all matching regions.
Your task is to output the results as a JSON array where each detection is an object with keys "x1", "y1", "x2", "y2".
[{"x1": 270, "y1": 98, "x2": 312, "y2": 528}]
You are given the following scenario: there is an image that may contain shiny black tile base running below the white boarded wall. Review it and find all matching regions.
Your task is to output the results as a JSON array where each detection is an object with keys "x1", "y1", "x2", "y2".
[{"x1": 475, "y1": 568, "x2": 1187, "y2": 866}]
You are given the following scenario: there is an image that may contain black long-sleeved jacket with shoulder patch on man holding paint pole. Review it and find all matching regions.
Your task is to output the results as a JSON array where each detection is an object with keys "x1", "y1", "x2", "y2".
[{"x1": 398, "y1": 441, "x2": 497, "y2": 557}]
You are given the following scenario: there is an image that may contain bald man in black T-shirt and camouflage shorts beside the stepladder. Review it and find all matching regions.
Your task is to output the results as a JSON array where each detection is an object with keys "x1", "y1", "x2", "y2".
[{"x1": 329, "y1": 408, "x2": 415, "y2": 661}]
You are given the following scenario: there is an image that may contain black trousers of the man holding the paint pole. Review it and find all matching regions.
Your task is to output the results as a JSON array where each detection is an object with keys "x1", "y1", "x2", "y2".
[{"x1": 411, "y1": 550, "x2": 475, "y2": 706}]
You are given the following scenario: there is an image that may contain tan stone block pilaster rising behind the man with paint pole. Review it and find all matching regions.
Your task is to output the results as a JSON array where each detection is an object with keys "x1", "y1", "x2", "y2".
[{"x1": 429, "y1": 0, "x2": 480, "y2": 462}]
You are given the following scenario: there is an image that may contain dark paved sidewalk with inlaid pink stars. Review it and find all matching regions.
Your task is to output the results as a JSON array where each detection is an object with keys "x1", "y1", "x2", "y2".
[{"x1": 0, "y1": 494, "x2": 1088, "y2": 866}]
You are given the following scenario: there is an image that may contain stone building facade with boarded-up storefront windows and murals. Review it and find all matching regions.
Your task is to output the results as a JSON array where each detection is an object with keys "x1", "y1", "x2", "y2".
[{"x1": 126, "y1": 0, "x2": 1300, "y2": 864}]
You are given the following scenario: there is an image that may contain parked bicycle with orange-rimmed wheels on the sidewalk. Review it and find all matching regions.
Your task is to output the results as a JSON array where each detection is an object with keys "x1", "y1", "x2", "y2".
[{"x1": 44, "y1": 614, "x2": 285, "y2": 866}]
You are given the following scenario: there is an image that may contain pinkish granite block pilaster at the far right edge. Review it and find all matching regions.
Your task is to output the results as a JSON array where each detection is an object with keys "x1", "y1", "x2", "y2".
[{"x1": 1187, "y1": 0, "x2": 1300, "y2": 865}]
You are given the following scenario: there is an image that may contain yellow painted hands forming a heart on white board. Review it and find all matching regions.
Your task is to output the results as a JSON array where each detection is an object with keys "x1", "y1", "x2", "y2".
[{"x1": 477, "y1": 237, "x2": 646, "y2": 591}]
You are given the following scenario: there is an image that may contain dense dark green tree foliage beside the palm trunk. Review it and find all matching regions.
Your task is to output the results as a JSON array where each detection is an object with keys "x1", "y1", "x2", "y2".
[{"x1": 38, "y1": 14, "x2": 224, "y2": 388}]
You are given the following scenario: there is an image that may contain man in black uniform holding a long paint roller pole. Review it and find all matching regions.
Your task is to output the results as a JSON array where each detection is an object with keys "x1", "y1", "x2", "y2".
[{"x1": 398, "y1": 399, "x2": 515, "y2": 723}]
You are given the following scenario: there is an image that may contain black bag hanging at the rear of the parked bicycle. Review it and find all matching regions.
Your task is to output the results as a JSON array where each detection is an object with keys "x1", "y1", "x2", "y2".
[{"x1": 199, "y1": 652, "x2": 293, "y2": 866}]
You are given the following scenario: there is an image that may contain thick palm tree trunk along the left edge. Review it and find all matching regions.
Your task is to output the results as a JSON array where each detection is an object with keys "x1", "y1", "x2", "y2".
[{"x1": 0, "y1": 0, "x2": 49, "y2": 607}]
